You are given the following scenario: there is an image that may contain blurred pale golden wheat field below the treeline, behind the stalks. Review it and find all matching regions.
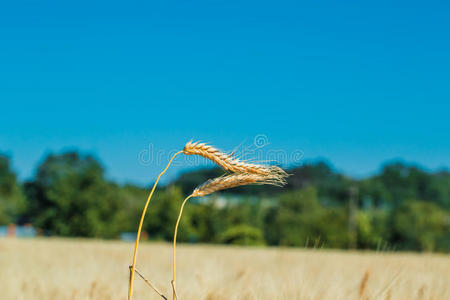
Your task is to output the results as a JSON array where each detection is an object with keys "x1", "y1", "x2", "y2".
[{"x1": 0, "y1": 239, "x2": 450, "y2": 300}]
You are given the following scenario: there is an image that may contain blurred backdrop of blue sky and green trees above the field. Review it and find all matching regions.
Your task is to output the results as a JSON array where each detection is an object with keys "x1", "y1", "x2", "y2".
[{"x1": 0, "y1": 1, "x2": 450, "y2": 252}]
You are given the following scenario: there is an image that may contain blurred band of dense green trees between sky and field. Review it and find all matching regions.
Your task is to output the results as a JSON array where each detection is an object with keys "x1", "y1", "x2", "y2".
[{"x1": 0, "y1": 152, "x2": 450, "y2": 252}]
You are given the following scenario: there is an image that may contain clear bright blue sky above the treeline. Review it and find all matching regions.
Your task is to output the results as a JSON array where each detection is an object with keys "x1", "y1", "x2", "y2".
[{"x1": 0, "y1": 0, "x2": 450, "y2": 184}]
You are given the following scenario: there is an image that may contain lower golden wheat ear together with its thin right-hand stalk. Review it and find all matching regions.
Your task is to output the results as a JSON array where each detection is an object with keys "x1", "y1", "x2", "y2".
[{"x1": 172, "y1": 173, "x2": 286, "y2": 300}]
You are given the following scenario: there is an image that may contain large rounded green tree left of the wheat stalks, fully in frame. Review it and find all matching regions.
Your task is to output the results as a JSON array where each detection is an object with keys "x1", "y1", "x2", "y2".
[{"x1": 27, "y1": 152, "x2": 123, "y2": 238}]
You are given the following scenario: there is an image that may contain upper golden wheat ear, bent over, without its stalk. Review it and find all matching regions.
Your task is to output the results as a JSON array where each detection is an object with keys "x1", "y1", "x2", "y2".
[{"x1": 183, "y1": 141, "x2": 286, "y2": 176}]
